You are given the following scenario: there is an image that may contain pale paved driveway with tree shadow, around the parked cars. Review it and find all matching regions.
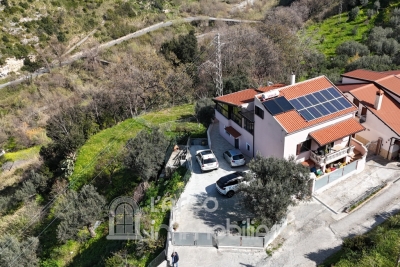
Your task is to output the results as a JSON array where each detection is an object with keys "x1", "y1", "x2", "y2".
[{"x1": 175, "y1": 142, "x2": 253, "y2": 232}]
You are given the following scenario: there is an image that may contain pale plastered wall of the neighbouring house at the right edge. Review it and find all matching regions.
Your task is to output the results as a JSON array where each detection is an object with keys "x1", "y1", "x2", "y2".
[{"x1": 345, "y1": 93, "x2": 400, "y2": 159}]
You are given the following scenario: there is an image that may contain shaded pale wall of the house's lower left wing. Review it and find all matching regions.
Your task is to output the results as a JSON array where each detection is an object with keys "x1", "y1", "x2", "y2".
[{"x1": 215, "y1": 111, "x2": 254, "y2": 157}]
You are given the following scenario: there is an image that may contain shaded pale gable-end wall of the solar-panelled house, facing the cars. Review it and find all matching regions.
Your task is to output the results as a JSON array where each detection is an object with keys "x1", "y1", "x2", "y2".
[{"x1": 254, "y1": 97, "x2": 286, "y2": 158}]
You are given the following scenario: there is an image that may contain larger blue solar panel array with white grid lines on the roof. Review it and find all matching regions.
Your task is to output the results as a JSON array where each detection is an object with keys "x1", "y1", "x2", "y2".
[{"x1": 289, "y1": 87, "x2": 352, "y2": 121}]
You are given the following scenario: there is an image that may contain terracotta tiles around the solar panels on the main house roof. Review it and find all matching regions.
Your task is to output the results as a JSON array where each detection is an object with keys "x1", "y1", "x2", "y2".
[{"x1": 274, "y1": 76, "x2": 357, "y2": 133}]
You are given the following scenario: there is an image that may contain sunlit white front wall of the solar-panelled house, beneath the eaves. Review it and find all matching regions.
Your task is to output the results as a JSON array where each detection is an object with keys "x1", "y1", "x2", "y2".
[{"x1": 284, "y1": 114, "x2": 353, "y2": 161}]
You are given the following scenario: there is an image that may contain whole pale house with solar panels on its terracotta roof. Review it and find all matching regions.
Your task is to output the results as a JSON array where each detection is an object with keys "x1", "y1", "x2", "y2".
[{"x1": 214, "y1": 76, "x2": 367, "y2": 190}]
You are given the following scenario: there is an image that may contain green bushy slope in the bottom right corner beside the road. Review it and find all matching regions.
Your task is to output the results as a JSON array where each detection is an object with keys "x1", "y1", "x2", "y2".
[{"x1": 321, "y1": 214, "x2": 400, "y2": 267}]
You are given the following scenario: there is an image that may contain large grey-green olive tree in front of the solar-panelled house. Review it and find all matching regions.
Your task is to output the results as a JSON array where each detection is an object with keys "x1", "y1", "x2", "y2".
[{"x1": 240, "y1": 154, "x2": 311, "y2": 228}]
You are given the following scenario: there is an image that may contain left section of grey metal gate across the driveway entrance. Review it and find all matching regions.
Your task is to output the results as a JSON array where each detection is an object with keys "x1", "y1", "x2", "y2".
[{"x1": 172, "y1": 232, "x2": 216, "y2": 247}]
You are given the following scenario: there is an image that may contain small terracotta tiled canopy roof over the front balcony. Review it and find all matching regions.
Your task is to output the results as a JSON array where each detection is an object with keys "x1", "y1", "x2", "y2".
[{"x1": 310, "y1": 118, "x2": 365, "y2": 146}]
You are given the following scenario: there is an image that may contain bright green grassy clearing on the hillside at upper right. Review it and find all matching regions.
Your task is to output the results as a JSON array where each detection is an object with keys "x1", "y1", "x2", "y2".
[{"x1": 306, "y1": 9, "x2": 376, "y2": 57}]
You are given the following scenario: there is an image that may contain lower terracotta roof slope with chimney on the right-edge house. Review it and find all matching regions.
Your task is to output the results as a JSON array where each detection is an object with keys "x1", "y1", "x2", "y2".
[{"x1": 350, "y1": 84, "x2": 400, "y2": 136}]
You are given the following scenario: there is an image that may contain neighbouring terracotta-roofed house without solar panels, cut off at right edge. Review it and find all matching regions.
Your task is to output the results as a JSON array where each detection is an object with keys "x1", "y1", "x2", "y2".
[{"x1": 337, "y1": 70, "x2": 400, "y2": 159}]
